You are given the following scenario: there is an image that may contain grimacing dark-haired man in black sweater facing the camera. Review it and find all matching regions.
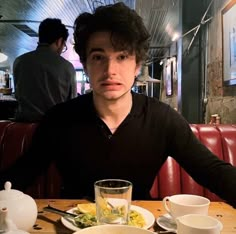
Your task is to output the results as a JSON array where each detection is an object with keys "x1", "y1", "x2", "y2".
[{"x1": 0, "y1": 3, "x2": 236, "y2": 206}]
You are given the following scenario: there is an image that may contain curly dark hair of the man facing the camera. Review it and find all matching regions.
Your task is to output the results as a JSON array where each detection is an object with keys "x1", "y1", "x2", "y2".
[{"x1": 74, "y1": 2, "x2": 150, "y2": 65}]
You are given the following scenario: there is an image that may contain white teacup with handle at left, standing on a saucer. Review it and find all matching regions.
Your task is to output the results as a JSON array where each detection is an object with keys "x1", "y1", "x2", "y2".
[{"x1": 163, "y1": 194, "x2": 210, "y2": 220}]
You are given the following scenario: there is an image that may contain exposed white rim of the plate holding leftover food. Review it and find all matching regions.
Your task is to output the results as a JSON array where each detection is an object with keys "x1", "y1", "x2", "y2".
[{"x1": 61, "y1": 205, "x2": 155, "y2": 231}]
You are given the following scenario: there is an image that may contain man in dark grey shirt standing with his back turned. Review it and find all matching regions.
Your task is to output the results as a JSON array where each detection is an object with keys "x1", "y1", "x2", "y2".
[{"x1": 13, "y1": 18, "x2": 77, "y2": 122}]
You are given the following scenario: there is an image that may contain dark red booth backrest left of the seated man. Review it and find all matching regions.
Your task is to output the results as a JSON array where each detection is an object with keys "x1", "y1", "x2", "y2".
[{"x1": 0, "y1": 120, "x2": 61, "y2": 198}]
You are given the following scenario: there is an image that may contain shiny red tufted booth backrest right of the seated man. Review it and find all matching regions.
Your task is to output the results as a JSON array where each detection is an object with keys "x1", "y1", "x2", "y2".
[{"x1": 150, "y1": 124, "x2": 236, "y2": 201}]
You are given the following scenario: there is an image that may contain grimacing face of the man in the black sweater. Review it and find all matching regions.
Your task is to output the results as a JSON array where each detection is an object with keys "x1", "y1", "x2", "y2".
[{"x1": 84, "y1": 32, "x2": 140, "y2": 100}]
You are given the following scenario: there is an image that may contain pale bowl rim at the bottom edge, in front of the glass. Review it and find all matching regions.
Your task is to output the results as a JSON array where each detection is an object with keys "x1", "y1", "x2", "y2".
[{"x1": 73, "y1": 224, "x2": 153, "y2": 234}]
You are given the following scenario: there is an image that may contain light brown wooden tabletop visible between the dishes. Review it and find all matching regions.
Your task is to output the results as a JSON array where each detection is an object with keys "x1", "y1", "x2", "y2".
[{"x1": 29, "y1": 199, "x2": 236, "y2": 234}]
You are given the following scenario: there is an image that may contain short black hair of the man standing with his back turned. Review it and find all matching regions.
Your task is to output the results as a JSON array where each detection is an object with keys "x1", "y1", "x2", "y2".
[{"x1": 39, "y1": 18, "x2": 69, "y2": 45}]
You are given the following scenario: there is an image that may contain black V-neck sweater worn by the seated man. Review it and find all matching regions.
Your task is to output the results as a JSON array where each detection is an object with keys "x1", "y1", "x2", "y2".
[{"x1": 0, "y1": 93, "x2": 236, "y2": 205}]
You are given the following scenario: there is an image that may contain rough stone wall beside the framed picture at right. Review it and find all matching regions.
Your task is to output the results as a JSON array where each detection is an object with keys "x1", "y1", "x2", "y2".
[{"x1": 205, "y1": 0, "x2": 236, "y2": 123}]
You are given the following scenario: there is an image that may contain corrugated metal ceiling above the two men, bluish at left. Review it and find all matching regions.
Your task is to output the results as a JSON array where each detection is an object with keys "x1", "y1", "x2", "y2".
[{"x1": 0, "y1": 0, "x2": 180, "y2": 67}]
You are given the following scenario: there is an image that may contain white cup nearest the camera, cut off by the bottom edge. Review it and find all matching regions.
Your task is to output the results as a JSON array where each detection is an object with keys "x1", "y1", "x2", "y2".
[{"x1": 176, "y1": 214, "x2": 223, "y2": 234}]
